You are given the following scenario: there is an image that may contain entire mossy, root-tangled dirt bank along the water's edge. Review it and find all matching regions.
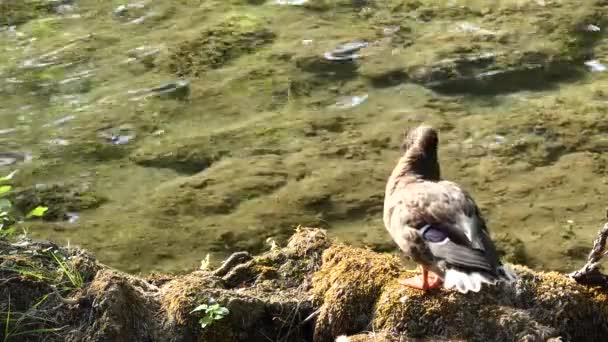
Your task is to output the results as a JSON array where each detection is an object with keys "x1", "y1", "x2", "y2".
[{"x1": 0, "y1": 228, "x2": 608, "y2": 342}]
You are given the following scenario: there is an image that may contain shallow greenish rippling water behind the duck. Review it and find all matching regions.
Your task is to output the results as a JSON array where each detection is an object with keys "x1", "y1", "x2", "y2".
[{"x1": 0, "y1": 0, "x2": 608, "y2": 272}]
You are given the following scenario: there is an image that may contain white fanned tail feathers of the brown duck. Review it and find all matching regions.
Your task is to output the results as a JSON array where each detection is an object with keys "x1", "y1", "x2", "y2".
[{"x1": 443, "y1": 265, "x2": 517, "y2": 293}]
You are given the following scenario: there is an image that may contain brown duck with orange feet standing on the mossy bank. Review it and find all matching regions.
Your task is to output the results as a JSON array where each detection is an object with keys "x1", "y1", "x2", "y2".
[{"x1": 383, "y1": 124, "x2": 516, "y2": 293}]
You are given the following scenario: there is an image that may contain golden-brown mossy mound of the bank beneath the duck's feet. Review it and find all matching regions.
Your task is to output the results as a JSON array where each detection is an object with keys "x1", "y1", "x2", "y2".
[{"x1": 312, "y1": 246, "x2": 608, "y2": 342}]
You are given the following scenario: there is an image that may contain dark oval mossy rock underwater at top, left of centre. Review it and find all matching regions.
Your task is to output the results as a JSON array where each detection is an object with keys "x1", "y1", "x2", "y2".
[{"x1": 168, "y1": 15, "x2": 276, "y2": 77}]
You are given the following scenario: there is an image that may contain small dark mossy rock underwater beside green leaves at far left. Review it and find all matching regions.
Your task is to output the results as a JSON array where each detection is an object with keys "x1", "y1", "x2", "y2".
[{"x1": 11, "y1": 184, "x2": 107, "y2": 221}]
